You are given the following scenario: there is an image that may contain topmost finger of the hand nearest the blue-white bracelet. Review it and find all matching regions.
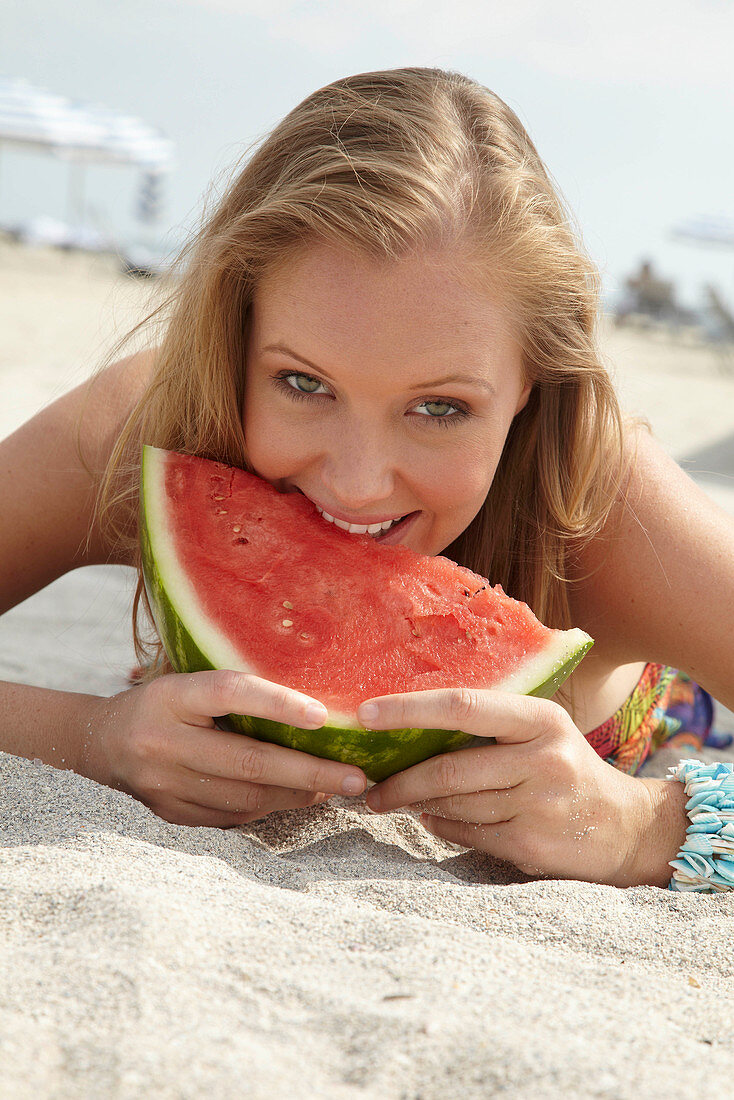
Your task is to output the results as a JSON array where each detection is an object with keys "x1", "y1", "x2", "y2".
[{"x1": 357, "y1": 688, "x2": 569, "y2": 744}]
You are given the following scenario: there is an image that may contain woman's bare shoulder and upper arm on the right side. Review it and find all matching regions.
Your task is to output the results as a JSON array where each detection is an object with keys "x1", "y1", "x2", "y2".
[{"x1": 572, "y1": 428, "x2": 734, "y2": 697}]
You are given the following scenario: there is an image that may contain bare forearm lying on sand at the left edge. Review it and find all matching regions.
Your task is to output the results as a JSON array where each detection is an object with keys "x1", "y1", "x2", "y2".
[{"x1": 0, "y1": 681, "x2": 103, "y2": 782}]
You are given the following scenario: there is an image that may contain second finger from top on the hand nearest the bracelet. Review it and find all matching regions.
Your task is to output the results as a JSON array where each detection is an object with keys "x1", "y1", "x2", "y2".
[{"x1": 366, "y1": 745, "x2": 533, "y2": 813}]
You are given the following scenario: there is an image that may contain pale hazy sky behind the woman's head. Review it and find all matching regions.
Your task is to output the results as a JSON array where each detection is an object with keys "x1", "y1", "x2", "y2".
[{"x1": 0, "y1": 0, "x2": 734, "y2": 305}]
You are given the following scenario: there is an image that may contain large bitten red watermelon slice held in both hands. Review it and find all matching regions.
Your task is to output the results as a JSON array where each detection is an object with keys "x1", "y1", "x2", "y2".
[{"x1": 141, "y1": 447, "x2": 592, "y2": 781}]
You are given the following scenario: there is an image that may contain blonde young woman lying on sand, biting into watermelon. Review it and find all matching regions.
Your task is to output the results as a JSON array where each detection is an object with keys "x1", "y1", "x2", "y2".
[{"x1": 0, "y1": 69, "x2": 734, "y2": 889}]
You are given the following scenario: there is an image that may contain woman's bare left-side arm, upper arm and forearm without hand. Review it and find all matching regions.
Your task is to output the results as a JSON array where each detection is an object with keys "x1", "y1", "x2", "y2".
[{"x1": 0, "y1": 353, "x2": 152, "y2": 770}]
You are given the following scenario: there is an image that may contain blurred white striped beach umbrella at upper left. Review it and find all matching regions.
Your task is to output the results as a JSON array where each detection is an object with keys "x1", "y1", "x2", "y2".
[{"x1": 0, "y1": 79, "x2": 174, "y2": 231}]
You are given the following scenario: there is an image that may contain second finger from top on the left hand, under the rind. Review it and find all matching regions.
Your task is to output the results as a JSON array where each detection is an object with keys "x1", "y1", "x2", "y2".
[{"x1": 175, "y1": 728, "x2": 366, "y2": 795}]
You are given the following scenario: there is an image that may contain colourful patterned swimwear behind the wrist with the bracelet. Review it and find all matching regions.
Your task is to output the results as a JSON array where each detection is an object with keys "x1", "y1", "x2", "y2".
[{"x1": 587, "y1": 664, "x2": 733, "y2": 776}]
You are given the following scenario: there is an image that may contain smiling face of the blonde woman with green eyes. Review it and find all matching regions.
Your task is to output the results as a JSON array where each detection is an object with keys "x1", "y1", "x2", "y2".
[{"x1": 243, "y1": 244, "x2": 530, "y2": 554}]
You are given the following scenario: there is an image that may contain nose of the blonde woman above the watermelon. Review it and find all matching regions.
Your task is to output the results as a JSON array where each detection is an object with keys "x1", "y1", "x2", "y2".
[{"x1": 321, "y1": 428, "x2": 396, "y2": 512}]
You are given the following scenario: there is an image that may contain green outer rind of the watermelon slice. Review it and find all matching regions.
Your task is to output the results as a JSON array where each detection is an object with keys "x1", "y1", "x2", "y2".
[{"x1": 140, "y1": 447, "x2": 593, "y2": 783}]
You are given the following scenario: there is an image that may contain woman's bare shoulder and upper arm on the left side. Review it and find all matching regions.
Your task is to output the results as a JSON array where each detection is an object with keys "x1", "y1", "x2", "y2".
[{"x1": 0, "y1": 350, "x2": 155, "y2": 612}]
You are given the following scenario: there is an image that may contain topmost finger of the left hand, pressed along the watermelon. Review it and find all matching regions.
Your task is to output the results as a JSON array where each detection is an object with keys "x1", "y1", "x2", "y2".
[{"x1": 169, "y1": 669, "x2": 328, "y2": 729}]
